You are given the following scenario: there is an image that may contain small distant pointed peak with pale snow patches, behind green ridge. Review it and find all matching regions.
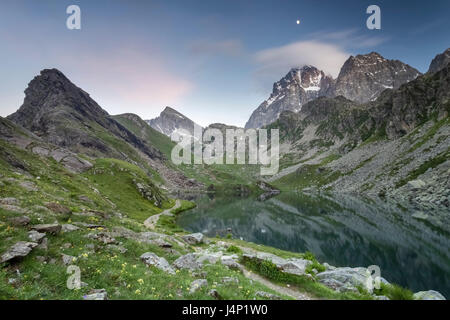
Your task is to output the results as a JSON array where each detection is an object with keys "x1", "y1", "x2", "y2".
[{"x1": 146, "y1": 107, "x2": 200, "y2": 137}]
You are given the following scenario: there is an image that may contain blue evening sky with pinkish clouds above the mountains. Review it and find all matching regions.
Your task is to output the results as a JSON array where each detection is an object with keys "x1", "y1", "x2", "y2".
[{"x1": 0, "y1": 0, "x2": 450, "y2": 126}]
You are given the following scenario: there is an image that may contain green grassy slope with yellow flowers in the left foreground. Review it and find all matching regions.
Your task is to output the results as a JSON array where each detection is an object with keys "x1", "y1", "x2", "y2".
[{"x1": 0, "y1": 141, "x2": 288, "y2": 299}]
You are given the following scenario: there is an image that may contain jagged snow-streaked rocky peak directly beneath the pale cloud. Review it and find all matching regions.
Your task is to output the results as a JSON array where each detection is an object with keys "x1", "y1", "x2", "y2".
[{"x1": 245, "y1": 66, "x2": 333, "y2": 129}]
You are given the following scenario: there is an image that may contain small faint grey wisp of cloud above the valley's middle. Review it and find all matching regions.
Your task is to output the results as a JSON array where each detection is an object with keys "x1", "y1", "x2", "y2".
[{"x1": 190, "y1": 39, "x2": 244, "y2": 56}]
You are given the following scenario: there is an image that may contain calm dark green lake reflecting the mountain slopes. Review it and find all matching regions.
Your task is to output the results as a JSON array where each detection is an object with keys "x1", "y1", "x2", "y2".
[{"x1": 178, "y1": 193, "x2": 450, "y2": 298}]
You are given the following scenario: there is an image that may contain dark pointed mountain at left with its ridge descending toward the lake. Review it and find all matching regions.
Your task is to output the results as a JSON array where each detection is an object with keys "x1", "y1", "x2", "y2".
[{"x1": 7, "y1": 69, "x2": 204, "y2": 188}]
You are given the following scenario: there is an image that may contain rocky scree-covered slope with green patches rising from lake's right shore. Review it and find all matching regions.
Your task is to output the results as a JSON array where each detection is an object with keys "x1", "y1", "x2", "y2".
[{"x1": 269, "y1": 60, "x2": 450, "y2": 225}]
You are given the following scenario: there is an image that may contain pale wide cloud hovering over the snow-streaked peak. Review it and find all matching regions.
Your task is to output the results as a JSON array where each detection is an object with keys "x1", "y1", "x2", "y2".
[{"x1": 254, "y1": 41, "x2": 350, "y2": 77}]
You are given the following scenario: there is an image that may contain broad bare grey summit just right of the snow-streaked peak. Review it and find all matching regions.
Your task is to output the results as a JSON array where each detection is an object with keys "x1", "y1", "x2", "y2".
[{"x1": 329, "y1": 52, "x2": 421, "y2": 103}]
